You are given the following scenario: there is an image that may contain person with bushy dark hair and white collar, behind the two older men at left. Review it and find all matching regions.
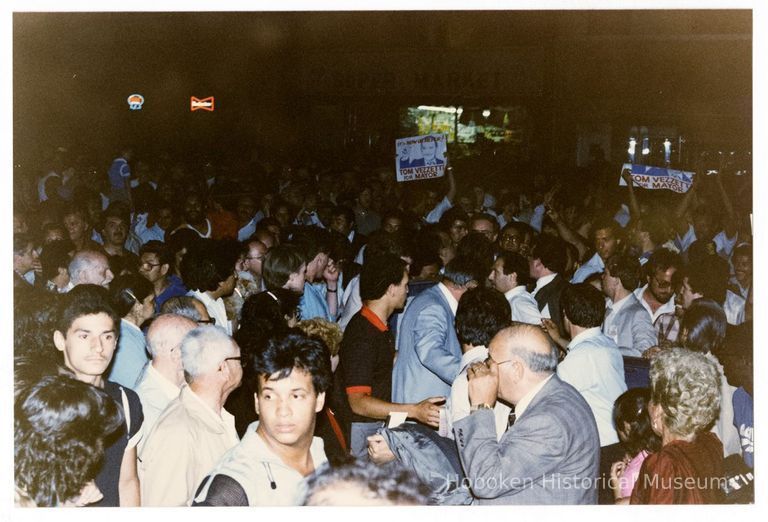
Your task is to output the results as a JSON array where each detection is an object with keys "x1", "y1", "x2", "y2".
[{"x1": 181, "y1": 240, "x2": 239, "y2": 335}]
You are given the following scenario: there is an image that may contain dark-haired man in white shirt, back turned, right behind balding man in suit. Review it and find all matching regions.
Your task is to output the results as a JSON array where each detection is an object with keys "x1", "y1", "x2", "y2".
[{"x1": 557, "y1": 282, "x2": 638, "y2": 500}]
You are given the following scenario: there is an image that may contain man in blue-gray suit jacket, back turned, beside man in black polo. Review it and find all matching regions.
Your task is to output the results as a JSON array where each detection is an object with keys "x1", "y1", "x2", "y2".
[{"x1": 392, "y1": 257, "x2": 485, "y2": 404}]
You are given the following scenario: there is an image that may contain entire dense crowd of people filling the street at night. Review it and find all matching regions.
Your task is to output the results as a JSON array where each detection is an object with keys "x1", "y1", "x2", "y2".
[{"x1": 13, "y1": 143, "x2": 754, "y2": 506}]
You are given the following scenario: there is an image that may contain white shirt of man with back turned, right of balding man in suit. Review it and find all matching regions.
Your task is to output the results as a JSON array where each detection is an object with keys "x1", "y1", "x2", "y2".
[{"x1": 557, "y1": 327, "x2": 627, "y2": 446}]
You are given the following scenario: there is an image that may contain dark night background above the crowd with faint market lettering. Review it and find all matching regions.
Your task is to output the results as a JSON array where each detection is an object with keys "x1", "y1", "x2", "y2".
[{"x1": 13, "y1": 10, "x2": 752, "y2": 173}]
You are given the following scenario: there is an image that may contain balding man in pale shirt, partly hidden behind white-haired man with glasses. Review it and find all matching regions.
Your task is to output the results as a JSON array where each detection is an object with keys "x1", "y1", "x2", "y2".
[{"x1": 136, "y1": 310, "x2": 202, "y2": 440}]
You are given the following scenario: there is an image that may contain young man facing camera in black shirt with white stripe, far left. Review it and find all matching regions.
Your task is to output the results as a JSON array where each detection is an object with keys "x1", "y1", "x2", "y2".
[{"x1": 53, "y1": 284, "x2": 144, "y2": 507}]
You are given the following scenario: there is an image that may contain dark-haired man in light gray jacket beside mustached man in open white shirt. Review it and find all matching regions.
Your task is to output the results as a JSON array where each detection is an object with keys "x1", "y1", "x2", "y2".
[{"x1": 603, "y1": 254, "x2": 658, "y2": 357}]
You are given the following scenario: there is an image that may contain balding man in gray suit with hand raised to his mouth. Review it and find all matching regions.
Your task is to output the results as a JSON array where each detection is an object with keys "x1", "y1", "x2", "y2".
[{"x1": 453, "y1": 325, "x2": 600, "y2": 504}]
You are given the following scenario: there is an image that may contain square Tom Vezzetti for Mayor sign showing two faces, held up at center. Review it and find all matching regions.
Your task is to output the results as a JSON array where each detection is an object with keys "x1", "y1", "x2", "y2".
[{"x1": 395, "y1": 134, "x2": 446, "y2": 181}]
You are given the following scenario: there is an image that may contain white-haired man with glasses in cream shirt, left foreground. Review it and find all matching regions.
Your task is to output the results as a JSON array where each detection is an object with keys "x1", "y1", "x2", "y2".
[{"x1": 139, "y1": 326, "x2": 243, "y2": 506}]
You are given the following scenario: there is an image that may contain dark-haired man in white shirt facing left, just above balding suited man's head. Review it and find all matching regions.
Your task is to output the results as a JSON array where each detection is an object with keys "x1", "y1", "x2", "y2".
[{"x1": 488, "y1": 251, "x2": 541, "y2": 325}]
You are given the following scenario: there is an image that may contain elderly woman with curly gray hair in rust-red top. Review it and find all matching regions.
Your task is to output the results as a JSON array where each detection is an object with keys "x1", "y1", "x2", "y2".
[{"x1": 630, "y1": 348, "x2": 724, "y2": 504}]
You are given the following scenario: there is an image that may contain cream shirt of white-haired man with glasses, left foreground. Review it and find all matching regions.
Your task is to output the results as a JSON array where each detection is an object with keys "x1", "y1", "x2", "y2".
[{"x1": 139, "y1": 386, "x2": 239, "y2": 506}]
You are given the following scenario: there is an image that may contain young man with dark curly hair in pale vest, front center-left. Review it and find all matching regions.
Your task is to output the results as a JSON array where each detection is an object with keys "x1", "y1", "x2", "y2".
[{"x1": 193, "y1": 329, "x2": 331, "y2": 506}]
